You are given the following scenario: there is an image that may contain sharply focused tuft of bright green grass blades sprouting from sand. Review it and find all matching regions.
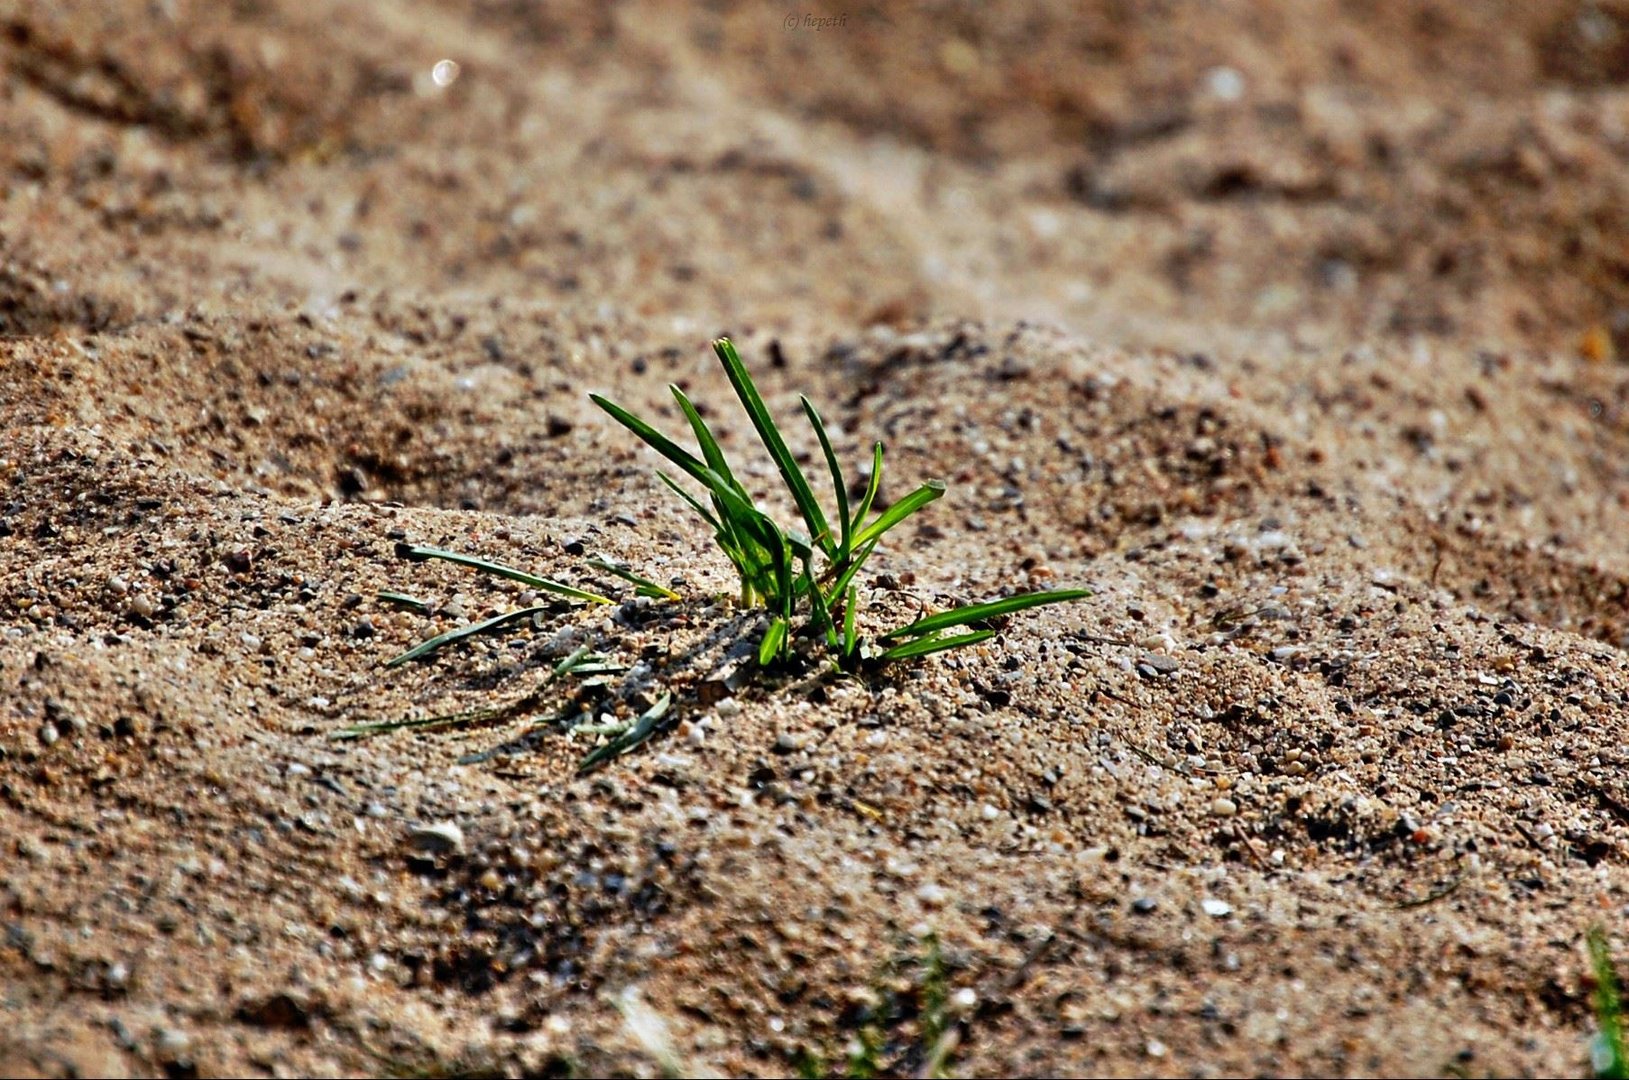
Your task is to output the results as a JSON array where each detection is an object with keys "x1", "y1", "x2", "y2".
[{"x1": 590, "y1": 337, "x2": 1088, "y2": 670}]
